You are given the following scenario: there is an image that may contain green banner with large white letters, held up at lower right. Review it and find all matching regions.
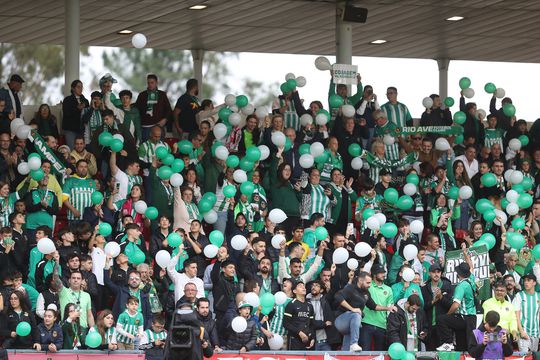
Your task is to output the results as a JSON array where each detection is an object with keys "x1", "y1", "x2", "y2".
[{"x1": 444, "y1": 245, "x2": 491, "y2": 300}]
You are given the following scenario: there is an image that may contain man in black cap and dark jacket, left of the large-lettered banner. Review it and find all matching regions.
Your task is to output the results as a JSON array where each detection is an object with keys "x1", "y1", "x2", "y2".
[{"x1": 422, "y1": 263, "x2": 454, "y2": 351}]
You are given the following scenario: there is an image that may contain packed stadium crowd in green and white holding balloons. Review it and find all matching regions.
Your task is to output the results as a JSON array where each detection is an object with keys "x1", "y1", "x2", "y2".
[{"x1": 0, "y1": 67, "x2": 540, "y2": 358}]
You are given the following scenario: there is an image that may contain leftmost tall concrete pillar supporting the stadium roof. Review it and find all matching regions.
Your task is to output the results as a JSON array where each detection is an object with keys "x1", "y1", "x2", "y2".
[{"x1": 64, "y1": 0, "x2": 81, "y2": 95}]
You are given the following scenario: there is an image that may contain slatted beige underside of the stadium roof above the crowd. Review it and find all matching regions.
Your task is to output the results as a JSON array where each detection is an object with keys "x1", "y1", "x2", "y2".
[{"x1": 0, "y1": 0, "x2": 540, "y2": 62}]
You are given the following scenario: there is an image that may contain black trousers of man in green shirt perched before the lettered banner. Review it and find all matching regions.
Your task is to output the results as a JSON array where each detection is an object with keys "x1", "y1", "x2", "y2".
[{"x1": 437, "y1": 313, "x2": 476, "y2": 351}]
